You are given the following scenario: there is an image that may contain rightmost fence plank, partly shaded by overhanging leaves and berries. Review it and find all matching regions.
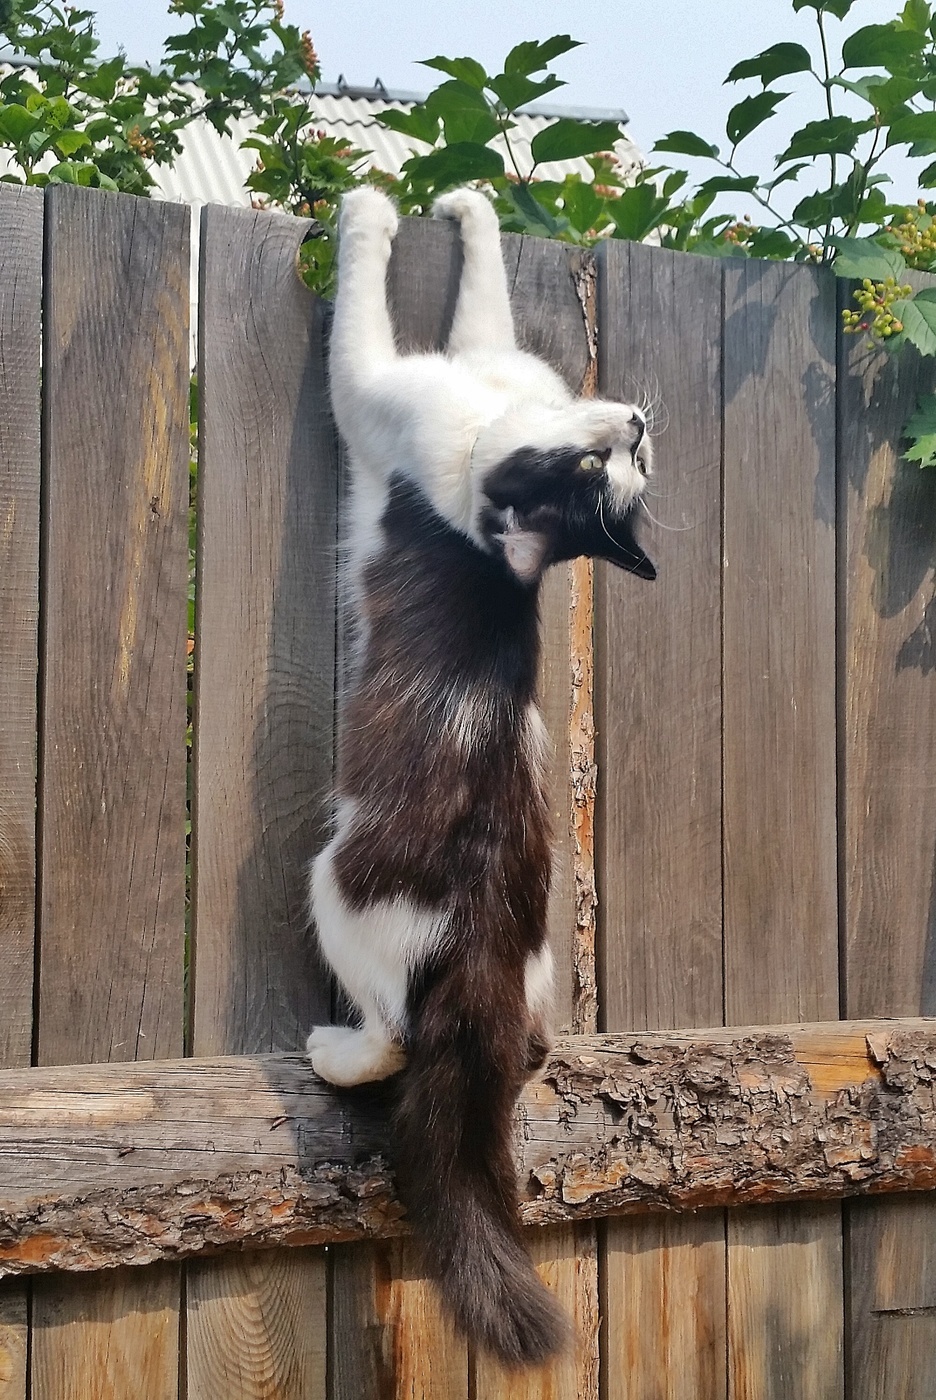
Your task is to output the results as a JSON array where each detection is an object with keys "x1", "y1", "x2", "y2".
[{"x1": 838, "y1": 289, "x2": 936, "y2": 1400}]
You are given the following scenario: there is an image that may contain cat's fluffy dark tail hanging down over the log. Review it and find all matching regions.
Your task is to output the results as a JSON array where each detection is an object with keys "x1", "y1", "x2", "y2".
[{"x1": 396, "y1": 965, "x2": 569, "y2": 1366}]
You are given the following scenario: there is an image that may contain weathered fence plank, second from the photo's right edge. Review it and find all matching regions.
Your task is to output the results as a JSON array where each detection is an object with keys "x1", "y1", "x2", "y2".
[{"x1": 723, "y1": 262, "x2": 844, "y2": 1400}]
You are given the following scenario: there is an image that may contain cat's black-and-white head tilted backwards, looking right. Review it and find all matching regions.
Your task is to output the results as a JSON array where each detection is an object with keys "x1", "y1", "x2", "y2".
[{"x1": 473, "y1": 399, "x2": 656, "y2": 584}]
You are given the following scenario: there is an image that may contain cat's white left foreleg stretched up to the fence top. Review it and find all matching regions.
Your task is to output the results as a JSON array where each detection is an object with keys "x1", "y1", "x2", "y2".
[{"x1": 329, "y1": 185, "x2": 399, "y2": 414}]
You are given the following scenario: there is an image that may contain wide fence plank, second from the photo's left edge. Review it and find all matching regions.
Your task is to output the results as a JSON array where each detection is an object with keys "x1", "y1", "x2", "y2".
[{"x1": 32, "y1": 185, "x2": 189, "y2": 1400}]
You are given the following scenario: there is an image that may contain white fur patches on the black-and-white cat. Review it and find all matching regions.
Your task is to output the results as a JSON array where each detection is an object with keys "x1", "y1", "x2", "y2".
[{"x1": 306, "y1": 188, "x2": 649, "y2": 1085}]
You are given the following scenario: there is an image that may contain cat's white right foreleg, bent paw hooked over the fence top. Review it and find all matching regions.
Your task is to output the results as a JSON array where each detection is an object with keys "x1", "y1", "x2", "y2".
[{"x1": 432, "y1": 189, "x2": 516, "y2": 356}]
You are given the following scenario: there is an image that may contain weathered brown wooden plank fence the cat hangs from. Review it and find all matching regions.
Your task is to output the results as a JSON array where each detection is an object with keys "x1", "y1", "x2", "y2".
[{"x1": 0, "y1": 186, "x2": 936, "y2": 1400}]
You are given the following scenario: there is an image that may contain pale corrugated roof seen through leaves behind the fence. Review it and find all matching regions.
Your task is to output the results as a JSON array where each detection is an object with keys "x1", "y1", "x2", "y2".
[{"x1": 153, "y1": 85, "x2": 641, "y2": 206}]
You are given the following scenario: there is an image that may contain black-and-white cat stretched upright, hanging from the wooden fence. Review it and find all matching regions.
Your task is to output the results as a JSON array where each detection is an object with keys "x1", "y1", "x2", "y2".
[{"x1": 306, "y1": 188, "x2": 655, "y2": 1365}]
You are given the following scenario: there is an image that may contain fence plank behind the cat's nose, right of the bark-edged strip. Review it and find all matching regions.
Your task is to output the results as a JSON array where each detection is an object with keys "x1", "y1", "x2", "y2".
[{"x1": 596, "y1": 242, "x2": 726, "y2": 1400}]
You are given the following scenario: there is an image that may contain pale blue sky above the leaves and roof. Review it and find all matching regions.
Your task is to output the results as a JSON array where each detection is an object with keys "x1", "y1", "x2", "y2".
[{"x1": 87, "y1": 0, "x2": 928, "y2": 221}]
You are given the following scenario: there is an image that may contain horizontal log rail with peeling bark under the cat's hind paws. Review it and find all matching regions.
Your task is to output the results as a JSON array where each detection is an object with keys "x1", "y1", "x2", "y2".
[{"x1": 0, "y1": 1019, "x2": 936, "y2": 1274}]
